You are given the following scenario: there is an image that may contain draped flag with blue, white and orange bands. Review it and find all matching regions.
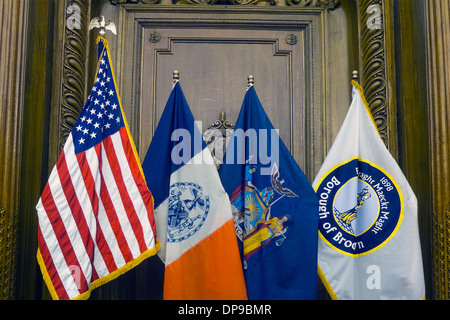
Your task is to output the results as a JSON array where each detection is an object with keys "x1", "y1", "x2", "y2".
[{"x1": 142, "y1": 82, "x2": 247, "y2": 300}]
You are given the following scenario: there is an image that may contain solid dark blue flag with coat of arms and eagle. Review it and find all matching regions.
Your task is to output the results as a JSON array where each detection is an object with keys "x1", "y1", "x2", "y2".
[{"x1": 219, "y1": 86, "x2": 318, "y2": 300}]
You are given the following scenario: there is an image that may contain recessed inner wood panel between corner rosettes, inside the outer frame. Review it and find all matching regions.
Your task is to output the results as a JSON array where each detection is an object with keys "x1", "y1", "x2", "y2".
[{"x1": 140, "y1": 28, "x2": 305, "y2": 169}]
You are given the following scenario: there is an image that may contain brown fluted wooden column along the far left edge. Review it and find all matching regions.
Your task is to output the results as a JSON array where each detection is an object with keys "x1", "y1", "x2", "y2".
[{"x1": 0, "y1": 0, "x2": 28, "y2": 300}]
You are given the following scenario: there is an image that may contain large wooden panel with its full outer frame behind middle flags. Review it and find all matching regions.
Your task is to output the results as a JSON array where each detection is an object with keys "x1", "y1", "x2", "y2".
[{"x1": 119, "y1": 5, "x2": 326, "y2": 179}]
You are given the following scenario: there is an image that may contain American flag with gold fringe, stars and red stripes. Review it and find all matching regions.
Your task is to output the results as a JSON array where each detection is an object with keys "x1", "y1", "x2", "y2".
[{"x1": 36, "y1": 38, "x2": 159, "y2": 299}]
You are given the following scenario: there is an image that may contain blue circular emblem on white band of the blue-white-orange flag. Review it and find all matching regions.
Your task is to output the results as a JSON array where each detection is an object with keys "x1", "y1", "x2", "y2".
[{"x1": 167, "y1": 182, "x2": 209, "y2": 242}]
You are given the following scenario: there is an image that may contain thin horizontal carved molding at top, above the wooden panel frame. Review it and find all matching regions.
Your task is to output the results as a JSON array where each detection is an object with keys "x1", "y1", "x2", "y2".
[{"x1": 110, "y1": 0, "x2": 341, "y2": 10}]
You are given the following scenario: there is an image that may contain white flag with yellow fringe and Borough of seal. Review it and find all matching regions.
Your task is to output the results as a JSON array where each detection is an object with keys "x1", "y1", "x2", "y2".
[{"x1": 313, "y1": 82, "x2": 425, "y2": 299}]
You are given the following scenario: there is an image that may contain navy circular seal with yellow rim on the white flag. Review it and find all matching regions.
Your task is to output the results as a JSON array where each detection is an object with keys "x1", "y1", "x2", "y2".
[{"x1": 316, "y1": 158, "x2": 404, "y2": 256}]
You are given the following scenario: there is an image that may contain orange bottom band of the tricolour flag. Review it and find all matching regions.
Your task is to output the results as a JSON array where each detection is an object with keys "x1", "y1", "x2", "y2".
[{"x1": 164, "y1": 220, "x2": 247, "y2": 300}]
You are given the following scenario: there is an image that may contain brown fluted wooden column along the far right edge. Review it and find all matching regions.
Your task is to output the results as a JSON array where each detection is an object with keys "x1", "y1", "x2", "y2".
[{"x1": 426, "y1": 0, "x2": 450, "y2": 300}]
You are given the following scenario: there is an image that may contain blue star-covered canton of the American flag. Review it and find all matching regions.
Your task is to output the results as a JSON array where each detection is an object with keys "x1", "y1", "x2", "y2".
[{"x1": 72, "y1": 51, "x2": 124, "y2": 153}]
